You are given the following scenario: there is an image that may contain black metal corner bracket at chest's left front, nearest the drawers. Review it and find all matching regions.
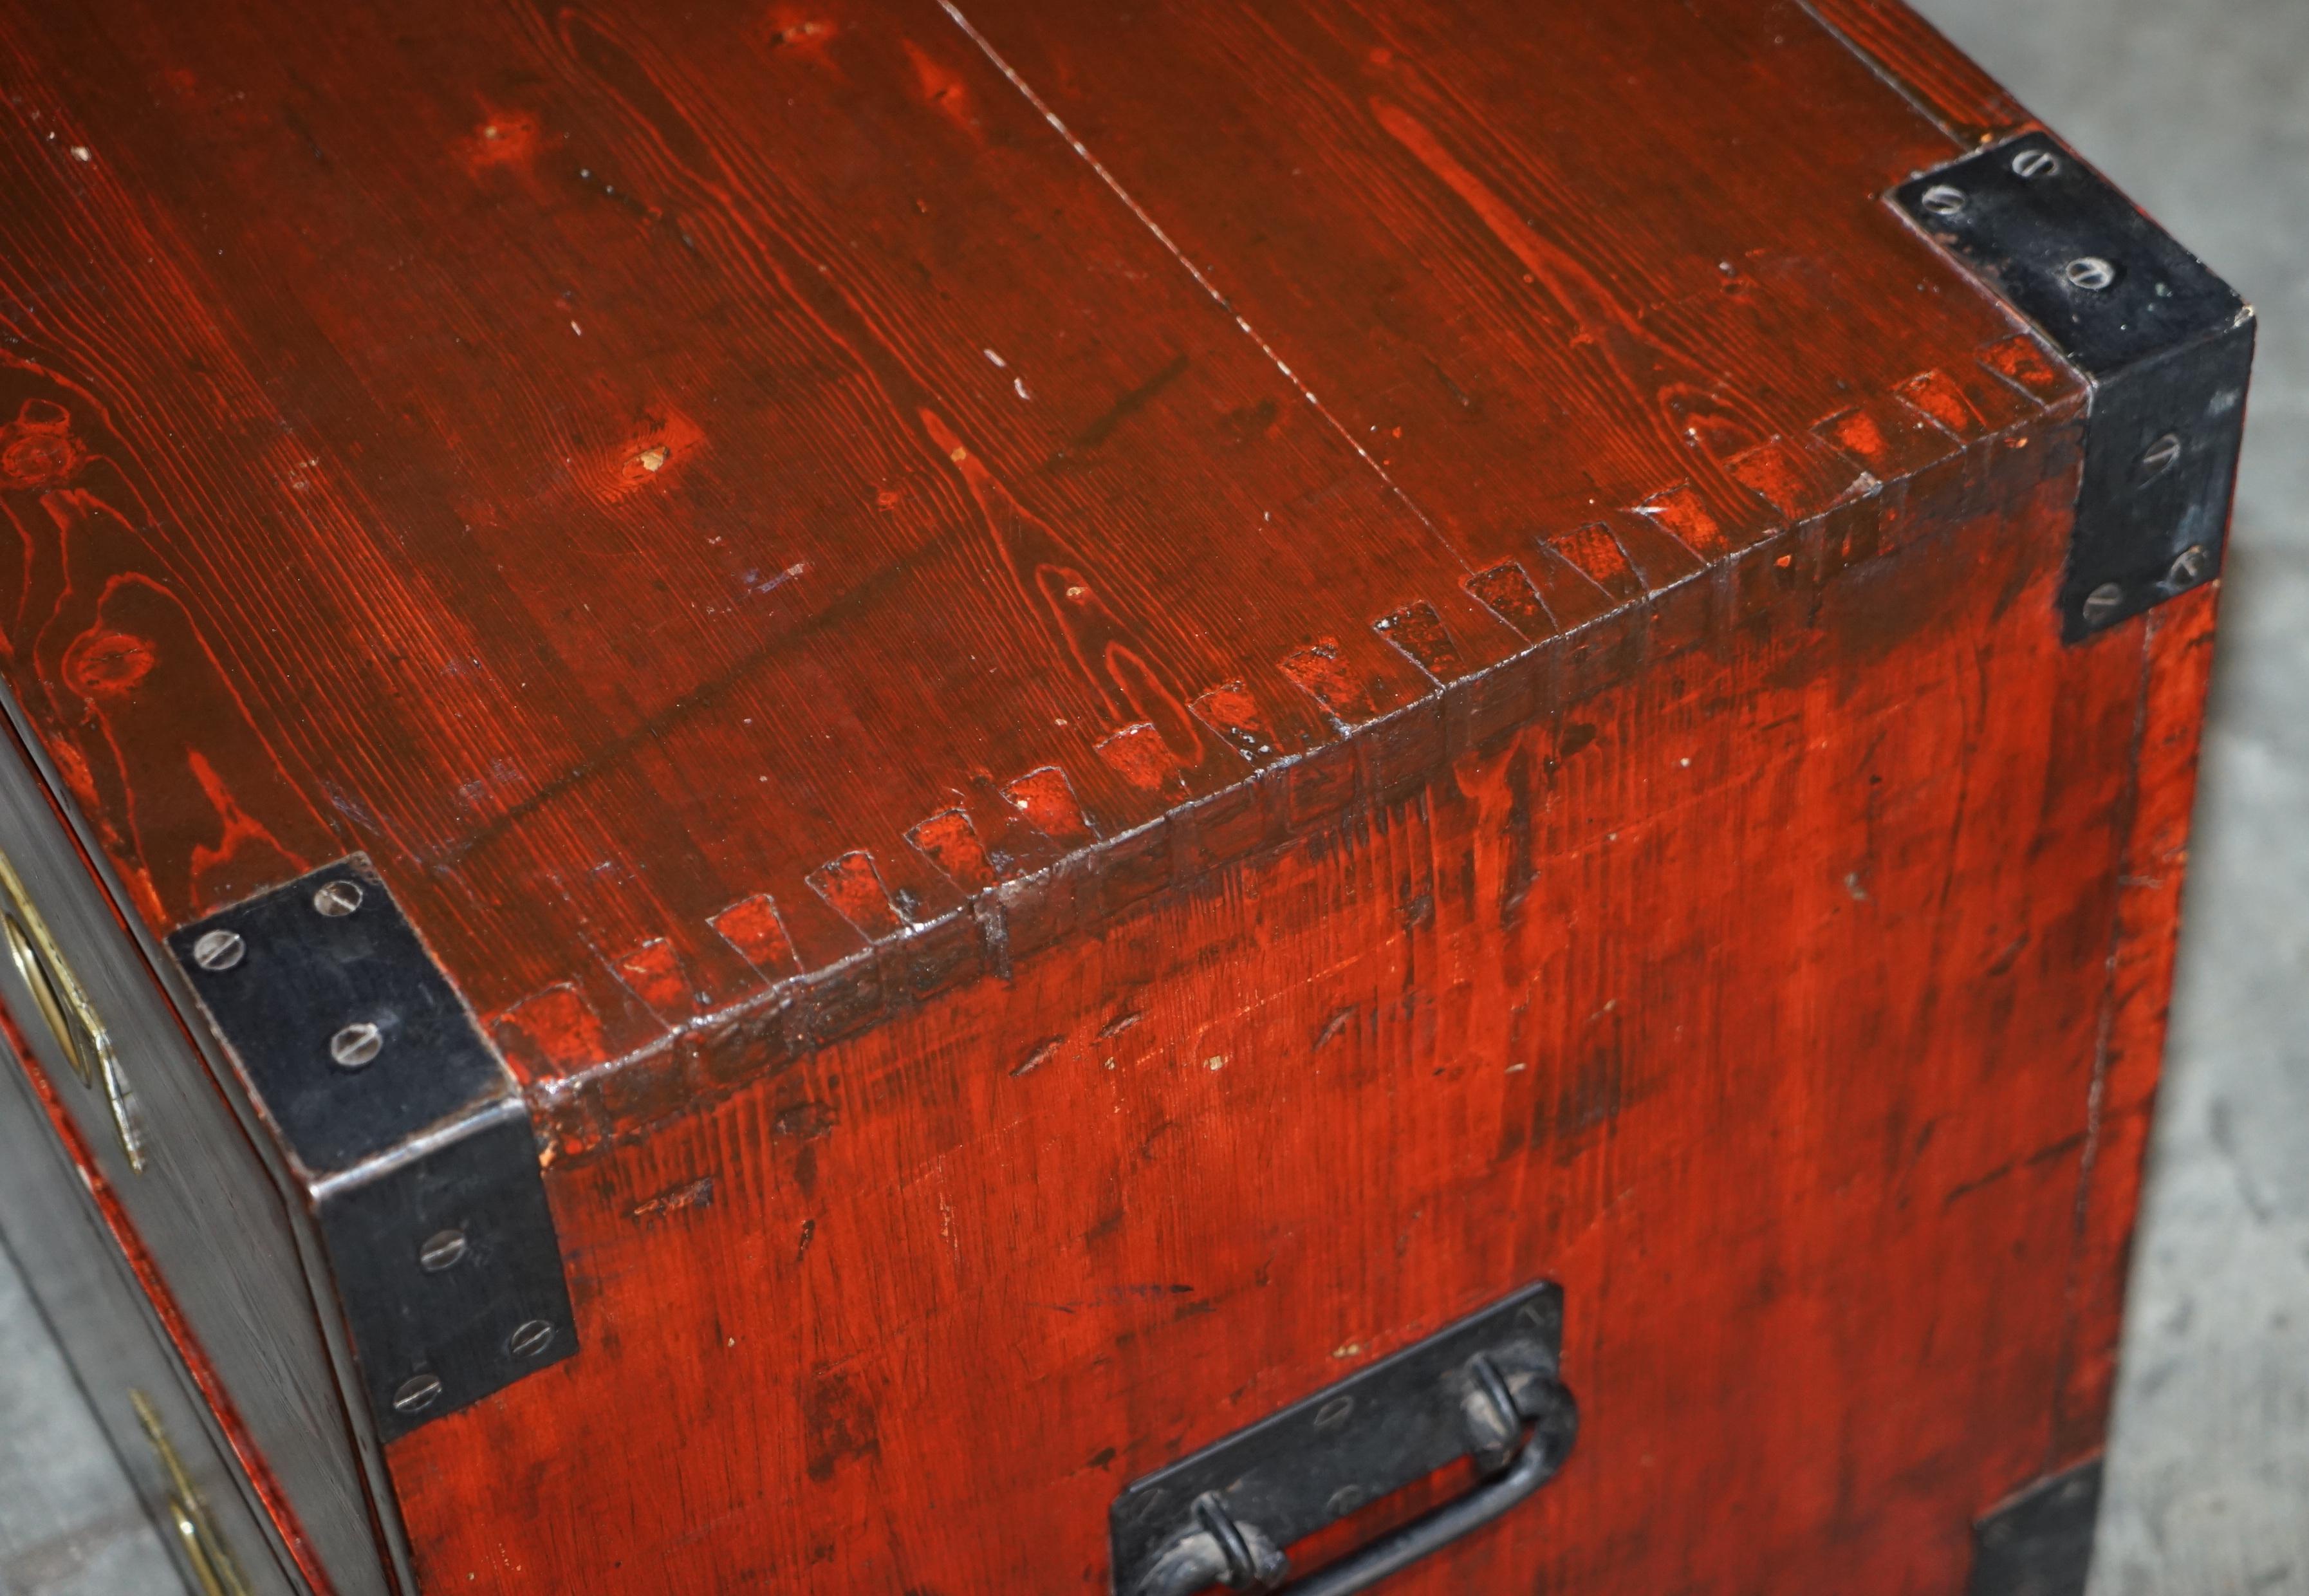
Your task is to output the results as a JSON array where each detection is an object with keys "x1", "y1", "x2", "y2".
[{"x1": 169, "y1": 855, "x2": 577, "y2": 1442}]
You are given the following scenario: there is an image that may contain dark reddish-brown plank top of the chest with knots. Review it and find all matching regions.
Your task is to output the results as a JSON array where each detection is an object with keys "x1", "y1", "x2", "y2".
[{"x1": 0, "y1": 0, "x2": 2059, "y2": 1070}]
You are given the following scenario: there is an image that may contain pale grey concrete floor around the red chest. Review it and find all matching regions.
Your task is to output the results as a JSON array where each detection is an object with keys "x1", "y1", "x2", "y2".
[{"x1": 0, "y1": 0, "x2": 2309, "y2": 1596}]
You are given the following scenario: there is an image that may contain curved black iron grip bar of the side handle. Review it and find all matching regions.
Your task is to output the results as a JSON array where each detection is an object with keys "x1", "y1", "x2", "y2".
[{"x1": 1138, "y1": 1381, "x2": 1579, "y2": 1596}]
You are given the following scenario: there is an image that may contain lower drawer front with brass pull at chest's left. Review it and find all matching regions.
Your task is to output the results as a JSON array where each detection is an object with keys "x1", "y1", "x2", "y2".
[{"x1": 0, "y1": 1011, "x2": 311, "y2": 1596}]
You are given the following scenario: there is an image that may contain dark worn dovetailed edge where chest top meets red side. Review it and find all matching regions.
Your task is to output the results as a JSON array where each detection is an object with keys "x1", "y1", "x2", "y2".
[{"x1": 524, "y1": 344, "x2": 2085, "y2": 1164}]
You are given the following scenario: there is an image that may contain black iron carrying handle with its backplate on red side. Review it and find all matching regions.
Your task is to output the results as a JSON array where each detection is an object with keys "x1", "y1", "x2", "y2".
[{"x1": 1108, "y1": 1282, "x2": 1579, "y2": 1596}]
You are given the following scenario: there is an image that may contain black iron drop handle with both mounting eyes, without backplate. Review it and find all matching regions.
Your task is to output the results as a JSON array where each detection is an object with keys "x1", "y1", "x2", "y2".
[{"x1": 1131, "y1": 1356, "x2": 1579, "y2": 1596}]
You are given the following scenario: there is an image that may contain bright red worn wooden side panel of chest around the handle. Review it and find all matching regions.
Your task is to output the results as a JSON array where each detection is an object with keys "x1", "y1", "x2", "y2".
[{"x1": 374, "y1": 425, "x2": 2198, "y2": 1593}]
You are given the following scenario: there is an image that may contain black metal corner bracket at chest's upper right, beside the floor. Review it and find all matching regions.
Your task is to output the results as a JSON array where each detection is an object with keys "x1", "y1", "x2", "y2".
[{"x1": 1891, "y1": 132, "x2": 2254, "y2": 642}]
